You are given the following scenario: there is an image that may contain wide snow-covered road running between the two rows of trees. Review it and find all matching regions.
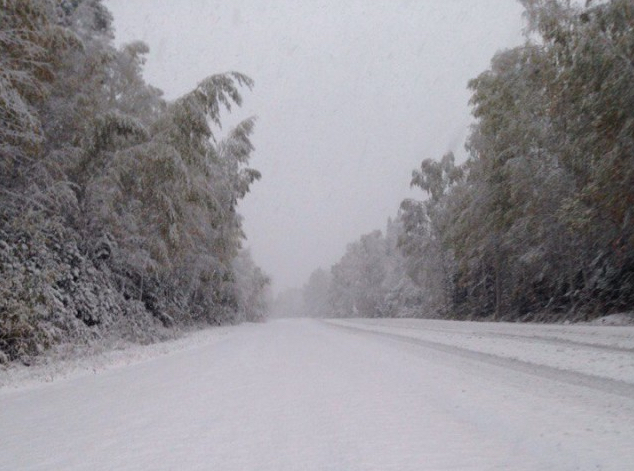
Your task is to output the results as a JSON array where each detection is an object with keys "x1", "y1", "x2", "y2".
[{"x1": 0, "y1": 320, "x2": 634, "y2": 471}]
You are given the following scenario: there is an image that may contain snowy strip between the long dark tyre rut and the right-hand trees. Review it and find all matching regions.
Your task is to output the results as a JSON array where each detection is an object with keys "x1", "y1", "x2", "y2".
[{"x1": 330, "y1": 319, "x2": 634, "y2": 391}]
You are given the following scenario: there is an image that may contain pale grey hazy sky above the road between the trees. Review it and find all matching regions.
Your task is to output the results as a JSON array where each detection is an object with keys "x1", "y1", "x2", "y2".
[{"x1": 105, "y1": 0, "x2": 523, "y2": 291}]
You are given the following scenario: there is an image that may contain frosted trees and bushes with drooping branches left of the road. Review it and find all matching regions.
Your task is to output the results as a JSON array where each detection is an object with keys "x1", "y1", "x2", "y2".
[{"x1": 0, "y1": 0, "x2": 269, "y2": 363}]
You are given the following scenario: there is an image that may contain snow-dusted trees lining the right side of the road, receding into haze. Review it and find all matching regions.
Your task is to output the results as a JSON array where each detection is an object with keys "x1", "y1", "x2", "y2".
[{"x1": 304, "y1": 0, "x2": 634, "y2": 321}]
